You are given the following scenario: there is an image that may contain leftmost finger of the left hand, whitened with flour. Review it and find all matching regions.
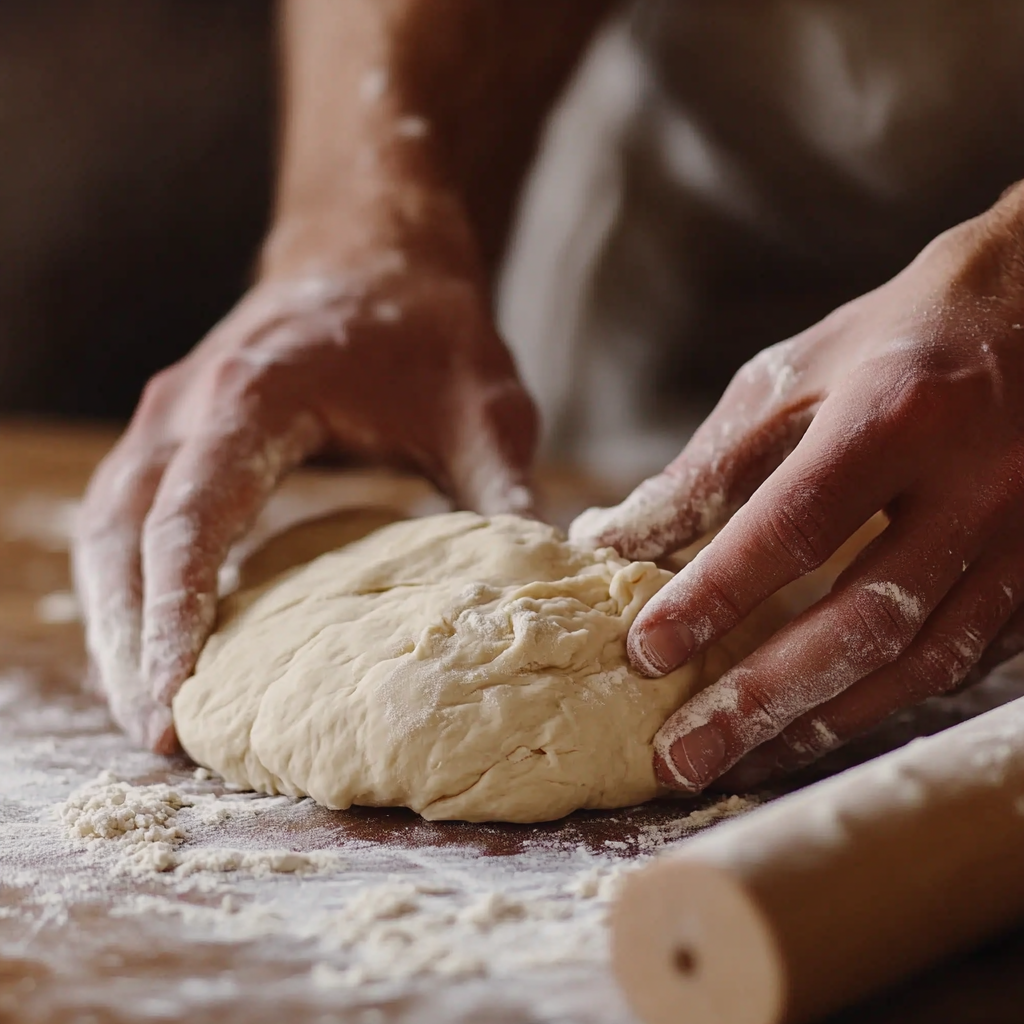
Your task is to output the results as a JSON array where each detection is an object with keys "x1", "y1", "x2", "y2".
[{"x1": 73, "y1": 434, "x2": 175, "y2": 753}]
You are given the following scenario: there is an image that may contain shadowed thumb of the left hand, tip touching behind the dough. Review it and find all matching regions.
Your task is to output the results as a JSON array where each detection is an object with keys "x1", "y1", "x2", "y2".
[{"x1": 442, "y1": 381, "x2": 538, "y2": 515}]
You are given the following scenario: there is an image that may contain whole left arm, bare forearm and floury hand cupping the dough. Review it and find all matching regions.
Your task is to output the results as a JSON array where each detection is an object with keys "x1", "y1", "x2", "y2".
[{"x1": 75, "y1": 0, "x2": 606, "y2": 751}]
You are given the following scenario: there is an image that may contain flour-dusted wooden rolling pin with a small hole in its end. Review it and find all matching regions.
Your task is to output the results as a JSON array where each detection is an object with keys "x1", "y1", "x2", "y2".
[{"x1": 611, "y1": 698, "x2": 1024, "y2": 1024}]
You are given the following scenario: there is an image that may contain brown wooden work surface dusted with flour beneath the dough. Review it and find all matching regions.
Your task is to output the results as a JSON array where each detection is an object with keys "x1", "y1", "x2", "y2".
[{"x1": 6, "y1": 417, "x2": 1024, "y2": 1024}]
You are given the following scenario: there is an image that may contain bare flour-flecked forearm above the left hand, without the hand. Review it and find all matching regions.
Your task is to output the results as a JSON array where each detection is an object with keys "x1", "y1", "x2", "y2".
[{"x1": 264, "y1": 0, "x2": 612, "y2": 278}]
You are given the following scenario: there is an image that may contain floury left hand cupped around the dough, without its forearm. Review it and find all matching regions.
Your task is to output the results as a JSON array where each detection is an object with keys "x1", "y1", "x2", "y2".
[{"x1": 74, "y1": 253, "x2": 536, "y2": 753}]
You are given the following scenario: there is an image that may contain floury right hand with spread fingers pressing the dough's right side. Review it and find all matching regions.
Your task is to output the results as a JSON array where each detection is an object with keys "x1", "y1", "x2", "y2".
[{"x1": 571, "y1": 187, "x2": 1024, "y2": 792}]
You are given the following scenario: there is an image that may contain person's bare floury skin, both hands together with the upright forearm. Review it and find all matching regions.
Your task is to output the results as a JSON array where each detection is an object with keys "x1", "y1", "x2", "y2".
[{"x1": 75, "y1": 0, "x2": 1024, "y2": 792}]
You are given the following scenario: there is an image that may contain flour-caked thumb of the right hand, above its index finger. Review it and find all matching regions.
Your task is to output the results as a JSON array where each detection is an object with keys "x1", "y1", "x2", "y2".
[{"x1": 569, "y1": 342, "x2": 818, "y2": 561}]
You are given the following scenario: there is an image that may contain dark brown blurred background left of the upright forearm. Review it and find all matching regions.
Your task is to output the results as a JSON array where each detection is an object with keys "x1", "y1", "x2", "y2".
[{"x1": 0, "y1": 0, "x2": 274, "y2": 419}]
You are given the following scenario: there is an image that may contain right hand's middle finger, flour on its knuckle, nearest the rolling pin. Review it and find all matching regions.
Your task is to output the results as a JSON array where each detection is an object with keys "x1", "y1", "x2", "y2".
[{"x1": 655, "y1": 502, "x2": 982, "y2": 792}]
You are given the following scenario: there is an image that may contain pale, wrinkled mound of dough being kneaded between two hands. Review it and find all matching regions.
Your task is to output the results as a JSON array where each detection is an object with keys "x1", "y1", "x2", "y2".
[{"x1": 174, "y1": 512, "x2": 720, "y2": 821}]
